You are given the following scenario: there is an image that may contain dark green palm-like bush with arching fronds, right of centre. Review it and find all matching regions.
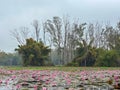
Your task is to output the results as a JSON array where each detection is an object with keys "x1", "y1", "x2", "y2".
[{"x1": 73, "y1": 40, "x2": 96, "y2": 66}]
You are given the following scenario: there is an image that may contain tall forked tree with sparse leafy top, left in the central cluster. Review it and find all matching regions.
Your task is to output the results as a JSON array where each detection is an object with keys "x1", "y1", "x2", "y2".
[{"x1": 46, "y1": 17, "x2": 62, "y2": 64}]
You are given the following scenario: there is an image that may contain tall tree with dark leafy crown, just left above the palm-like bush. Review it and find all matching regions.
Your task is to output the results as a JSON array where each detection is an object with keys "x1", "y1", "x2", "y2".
[{"x1": 68, "y1": 22, "x2": 86, "y2": 64}]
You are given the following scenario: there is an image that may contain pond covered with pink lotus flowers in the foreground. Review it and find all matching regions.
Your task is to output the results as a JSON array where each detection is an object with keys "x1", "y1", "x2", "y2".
[{"x1": 0, "y1": 67, "x2": 120, "y2": 90}]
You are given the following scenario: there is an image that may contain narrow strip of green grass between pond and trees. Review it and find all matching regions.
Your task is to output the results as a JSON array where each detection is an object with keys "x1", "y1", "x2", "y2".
[{"x1": 4, "y1": 66, "x2": 120, "y2": 71}]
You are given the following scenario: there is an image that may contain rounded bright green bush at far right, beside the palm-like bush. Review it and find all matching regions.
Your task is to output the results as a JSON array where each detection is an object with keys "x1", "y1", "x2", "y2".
[{"x1": 95, "y1": 49, "x2": 119, "y2": 67}]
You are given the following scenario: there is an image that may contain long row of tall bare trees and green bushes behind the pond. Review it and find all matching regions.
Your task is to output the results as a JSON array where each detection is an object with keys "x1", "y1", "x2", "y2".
[{"x1": 12, "y1": 16, "x2": 120, "y2": 66}]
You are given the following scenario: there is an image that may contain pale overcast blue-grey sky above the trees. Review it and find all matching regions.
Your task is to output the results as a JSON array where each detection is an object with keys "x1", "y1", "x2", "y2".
[{"x1": 0, "y1": 0, "x2": 120, "y2": 52}]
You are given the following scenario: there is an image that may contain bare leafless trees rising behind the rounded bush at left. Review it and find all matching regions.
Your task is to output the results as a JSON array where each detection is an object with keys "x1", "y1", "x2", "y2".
[{"x1": 10, "y1": 20, "x2": 42, "y2": 45}]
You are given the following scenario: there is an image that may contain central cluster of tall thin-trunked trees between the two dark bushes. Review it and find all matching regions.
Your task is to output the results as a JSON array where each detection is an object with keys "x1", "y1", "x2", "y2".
[{"x1": 45, "y1": 16, "x2": 86, "y2": 65}]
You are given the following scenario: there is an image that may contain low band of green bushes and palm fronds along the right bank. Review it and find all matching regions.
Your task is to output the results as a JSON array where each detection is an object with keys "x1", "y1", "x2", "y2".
[{"x1": 67, "y1": 45, "x2": 120, "y2": 67}]
